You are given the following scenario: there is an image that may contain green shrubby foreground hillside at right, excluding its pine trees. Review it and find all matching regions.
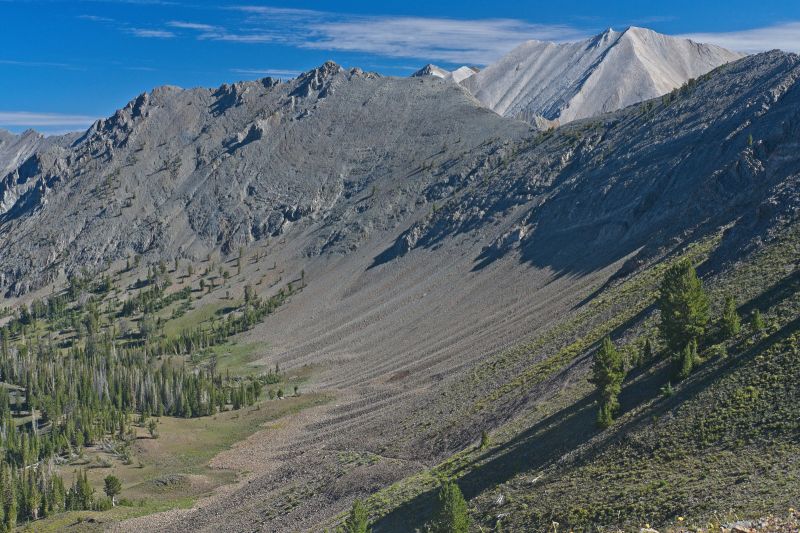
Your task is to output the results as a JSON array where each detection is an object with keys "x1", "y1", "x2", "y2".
[{"x1": 342, "y1": 218, "x2": 800, "y2": 531}]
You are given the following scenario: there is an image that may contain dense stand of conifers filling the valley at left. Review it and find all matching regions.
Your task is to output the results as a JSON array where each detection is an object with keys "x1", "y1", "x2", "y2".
[{"x1": 0, "y1": 256, "x2": 297, "y2": 531}]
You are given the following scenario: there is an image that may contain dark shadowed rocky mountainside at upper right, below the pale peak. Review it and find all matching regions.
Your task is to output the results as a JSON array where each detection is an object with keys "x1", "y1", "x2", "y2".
[{"x1": 392, "y1": 52, "x2": 800, "y2": 271}]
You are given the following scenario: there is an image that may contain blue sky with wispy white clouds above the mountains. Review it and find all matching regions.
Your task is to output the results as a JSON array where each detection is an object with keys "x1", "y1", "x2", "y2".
[{"x1": 0, "y1": 0, "x2": 800, "y2": 133}]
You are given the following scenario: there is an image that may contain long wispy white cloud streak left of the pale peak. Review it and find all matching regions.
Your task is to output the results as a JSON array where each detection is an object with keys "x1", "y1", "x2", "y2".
[{"x1": 161, "y1": 5, "x2": 588, "y2": 65}]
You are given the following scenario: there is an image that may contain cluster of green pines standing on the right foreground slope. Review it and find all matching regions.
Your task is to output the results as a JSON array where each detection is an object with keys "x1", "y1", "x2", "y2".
[{"x1": 590, "y1": 260, "x2": 765, "y2": 428}]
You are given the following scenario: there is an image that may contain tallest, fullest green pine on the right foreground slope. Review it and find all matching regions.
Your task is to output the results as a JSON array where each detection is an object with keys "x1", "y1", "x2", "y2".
[{"x1": 658, "y1": 260, "x2": 709, "y2": 354}]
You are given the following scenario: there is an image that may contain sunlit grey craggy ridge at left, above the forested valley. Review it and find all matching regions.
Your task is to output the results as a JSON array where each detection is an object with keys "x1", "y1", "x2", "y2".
[{"x1": 0, "y1": 63, "x2": 527, "y2": 294}]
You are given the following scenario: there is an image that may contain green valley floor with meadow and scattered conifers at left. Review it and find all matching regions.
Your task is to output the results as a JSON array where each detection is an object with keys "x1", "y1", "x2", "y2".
[{"x1": 0, "y1": 251, "x2": 332, "y2": 531}]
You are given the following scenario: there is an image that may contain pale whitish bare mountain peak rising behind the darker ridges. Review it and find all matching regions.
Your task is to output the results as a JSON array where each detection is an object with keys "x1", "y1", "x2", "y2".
[{"x1": 463, "y1": 27, "x2": 742, "y2": 126}]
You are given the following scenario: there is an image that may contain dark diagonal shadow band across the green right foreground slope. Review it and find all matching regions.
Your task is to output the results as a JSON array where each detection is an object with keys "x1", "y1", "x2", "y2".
[{"x1": 375, "y1": 286, "x2": 800, "y2": 532}]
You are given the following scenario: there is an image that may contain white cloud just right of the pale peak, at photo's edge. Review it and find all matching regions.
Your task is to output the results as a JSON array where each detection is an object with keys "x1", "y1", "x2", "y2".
[{"x1": 681, "y1": 22, "x2": 800, "y2": 53}]
